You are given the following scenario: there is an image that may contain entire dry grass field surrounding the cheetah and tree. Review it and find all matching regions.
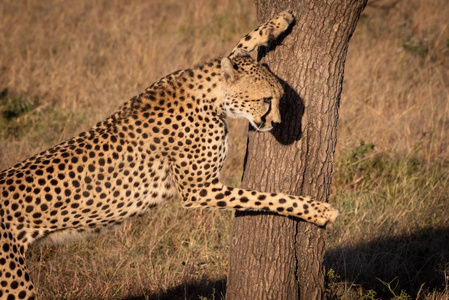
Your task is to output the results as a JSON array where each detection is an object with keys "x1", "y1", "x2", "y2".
[{"x1": 0, "y1": 0, "x2": 449, "y2": 300}]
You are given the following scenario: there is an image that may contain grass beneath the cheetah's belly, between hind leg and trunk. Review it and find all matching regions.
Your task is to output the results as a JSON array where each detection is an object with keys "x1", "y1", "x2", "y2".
[{"x1": 28, "y1": 203, "x2": 231, "y2": 299}]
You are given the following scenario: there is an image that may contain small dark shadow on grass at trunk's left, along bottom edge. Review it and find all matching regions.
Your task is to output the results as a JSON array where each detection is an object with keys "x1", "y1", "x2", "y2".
[{"x1": 124, "y1": 278, "x2": 226, "y2": 300}]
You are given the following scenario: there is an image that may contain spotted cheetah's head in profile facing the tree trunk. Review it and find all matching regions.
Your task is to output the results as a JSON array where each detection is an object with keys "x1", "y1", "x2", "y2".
[{"x1": 221, "y1": 54, "x2": 284, "y2": 131}]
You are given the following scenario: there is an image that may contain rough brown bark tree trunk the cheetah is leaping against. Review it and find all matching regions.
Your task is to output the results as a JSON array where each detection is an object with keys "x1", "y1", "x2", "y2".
[{"x1": 226, "y1": 0, "x2": 366, "y2": 300}]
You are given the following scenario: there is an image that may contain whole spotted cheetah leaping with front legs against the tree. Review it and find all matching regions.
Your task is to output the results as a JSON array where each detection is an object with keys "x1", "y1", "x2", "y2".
[{"x1": 0, "y1": 11, "x2": 339, "y2": 299}]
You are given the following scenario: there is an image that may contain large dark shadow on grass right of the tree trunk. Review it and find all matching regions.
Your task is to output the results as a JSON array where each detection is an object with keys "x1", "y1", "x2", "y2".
[{"x1": 325, "y1": 228, "x2": 449, "y2": 298}]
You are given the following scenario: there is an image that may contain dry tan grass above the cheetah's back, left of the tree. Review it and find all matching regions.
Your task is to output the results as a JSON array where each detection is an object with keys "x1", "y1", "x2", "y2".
[{"x1": 0, "y1": 0, "x2": 252, "y2": 169}]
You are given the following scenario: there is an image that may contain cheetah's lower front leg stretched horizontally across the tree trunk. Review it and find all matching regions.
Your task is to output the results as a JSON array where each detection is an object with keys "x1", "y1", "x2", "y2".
[{"x1": 181, "y1": 180, "x2": 340, "y2": 226}]
